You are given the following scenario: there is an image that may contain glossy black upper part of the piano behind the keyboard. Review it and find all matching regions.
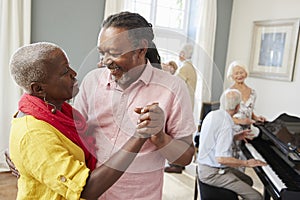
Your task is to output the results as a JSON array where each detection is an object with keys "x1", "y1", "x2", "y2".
[{"x1": 264, "y1": 113, "x2": 300, "y2": 155}]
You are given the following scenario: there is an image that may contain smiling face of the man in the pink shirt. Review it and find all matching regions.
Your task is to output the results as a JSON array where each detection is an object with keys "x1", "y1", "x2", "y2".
[{"x1": 97, "y1": 27, "x2": 140, "y2": 80}]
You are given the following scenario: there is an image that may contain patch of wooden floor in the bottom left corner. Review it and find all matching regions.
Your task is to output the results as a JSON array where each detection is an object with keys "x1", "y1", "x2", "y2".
[{"x1": 0, "y1": 172, "x2": 17, "y2": 200}]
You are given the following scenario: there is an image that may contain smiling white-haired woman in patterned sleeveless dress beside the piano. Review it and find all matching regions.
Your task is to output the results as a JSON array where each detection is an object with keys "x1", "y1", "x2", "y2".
[{"x1": 227, "y1": 61, "x2": 266, "y2": 167}]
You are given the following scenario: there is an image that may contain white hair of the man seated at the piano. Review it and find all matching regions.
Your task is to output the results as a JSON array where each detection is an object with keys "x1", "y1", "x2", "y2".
[{"x1": 220, "y1": 89, "x2": 242, "y2": 110}]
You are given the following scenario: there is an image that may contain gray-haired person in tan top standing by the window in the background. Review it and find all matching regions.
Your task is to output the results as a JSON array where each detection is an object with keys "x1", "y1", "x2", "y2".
[{"x1": 165, "y1": 44, "x2": 197, "y2": 173}]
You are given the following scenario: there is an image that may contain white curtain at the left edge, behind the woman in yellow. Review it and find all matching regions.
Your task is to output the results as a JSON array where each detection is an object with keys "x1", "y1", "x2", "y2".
[{"x1": 0, "y1": 0, "x2": 31, "y2": 151}]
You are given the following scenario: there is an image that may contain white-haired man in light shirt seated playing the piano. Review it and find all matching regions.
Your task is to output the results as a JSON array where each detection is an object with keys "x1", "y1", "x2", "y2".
[{"x1": 197, "y1": 89, "x2": 266, "y2": 200}]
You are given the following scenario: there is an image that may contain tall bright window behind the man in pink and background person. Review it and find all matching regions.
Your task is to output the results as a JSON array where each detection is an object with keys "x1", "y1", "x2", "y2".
[{"x1": 123, "y1": 0, "x2": 204, "y2": 123}]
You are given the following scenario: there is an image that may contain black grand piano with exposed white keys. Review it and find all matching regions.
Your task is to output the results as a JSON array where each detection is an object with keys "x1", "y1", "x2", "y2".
[{"x1": 242, "y1": 113, "x2": 300, "y2": 200}]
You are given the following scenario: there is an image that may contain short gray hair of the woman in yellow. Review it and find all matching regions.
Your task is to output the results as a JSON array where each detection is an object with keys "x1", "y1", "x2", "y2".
[{"x1": 9, "y1": 42, "x2": 64, "y2": 93}]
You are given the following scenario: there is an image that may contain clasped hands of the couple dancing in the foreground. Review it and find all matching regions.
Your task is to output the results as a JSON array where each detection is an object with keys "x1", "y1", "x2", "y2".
[{"x1": 134, "y1": 103, "x2": 165, "y2": 138}]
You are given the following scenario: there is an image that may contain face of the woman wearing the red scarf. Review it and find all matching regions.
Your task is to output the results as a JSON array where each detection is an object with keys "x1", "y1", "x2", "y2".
[{"x1": 43, "y1": 49, "x2": 79, "y2": 105}]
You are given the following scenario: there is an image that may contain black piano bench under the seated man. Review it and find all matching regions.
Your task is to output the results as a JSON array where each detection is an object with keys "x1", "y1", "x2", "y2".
[{"x1": 198, "y1": 179, "x2": 239, "y2": 200}]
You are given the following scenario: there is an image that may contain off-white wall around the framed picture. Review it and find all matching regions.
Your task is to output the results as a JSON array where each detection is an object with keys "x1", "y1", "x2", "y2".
[{"x1": 225, "y1": 0, "x2": 300, "y2": 120}]
